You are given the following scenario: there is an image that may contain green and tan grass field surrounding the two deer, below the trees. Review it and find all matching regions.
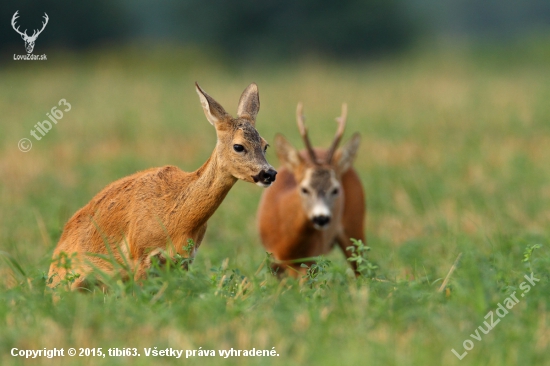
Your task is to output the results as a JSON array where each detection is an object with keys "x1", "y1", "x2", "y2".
[{"x1": 0, "y1": 42, "x2": 550, "y2": 366}]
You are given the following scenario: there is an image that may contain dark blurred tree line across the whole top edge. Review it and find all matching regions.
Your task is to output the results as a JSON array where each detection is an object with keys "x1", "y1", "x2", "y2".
[{"x1": 0, "y1": 0, "x2": 550, "y2": 59}]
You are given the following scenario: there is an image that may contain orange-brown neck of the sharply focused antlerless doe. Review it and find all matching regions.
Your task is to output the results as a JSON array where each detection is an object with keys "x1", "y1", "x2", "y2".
[{"x1": 177, "y1": 150, "x2": 237, "y2": 232}]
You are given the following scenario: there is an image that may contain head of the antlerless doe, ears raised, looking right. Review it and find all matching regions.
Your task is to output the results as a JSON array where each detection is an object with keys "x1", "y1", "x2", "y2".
[{"x1": 195, "y1": 83, "x2": 277, "y2": 187}]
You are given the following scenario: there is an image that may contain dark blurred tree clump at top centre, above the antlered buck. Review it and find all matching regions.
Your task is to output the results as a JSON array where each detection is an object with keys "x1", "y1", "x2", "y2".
[{"x1": 170, "y1": 0, "x2": 414, "y2": 56}]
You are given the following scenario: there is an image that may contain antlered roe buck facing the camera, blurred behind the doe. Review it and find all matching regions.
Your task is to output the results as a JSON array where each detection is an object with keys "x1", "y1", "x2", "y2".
[{"x1": 257, "y1": 103, "x2": 365, "y2": 276}]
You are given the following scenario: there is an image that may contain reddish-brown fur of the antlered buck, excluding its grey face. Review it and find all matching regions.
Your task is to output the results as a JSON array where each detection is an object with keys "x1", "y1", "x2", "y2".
[{"x1": 258, "y1": 106, "x2": 365, "y2": 275}]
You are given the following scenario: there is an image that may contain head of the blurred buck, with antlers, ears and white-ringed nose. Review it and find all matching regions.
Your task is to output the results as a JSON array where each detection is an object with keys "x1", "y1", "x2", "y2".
[{"x1": 275, "y1": 103, "x2": 360, "y2": 230}]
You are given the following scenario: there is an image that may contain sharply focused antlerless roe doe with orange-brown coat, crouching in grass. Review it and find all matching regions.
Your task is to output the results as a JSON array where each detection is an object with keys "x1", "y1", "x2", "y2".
[{"x1": 48, "y1": 83, "x2": 277, "y2": 290}]
